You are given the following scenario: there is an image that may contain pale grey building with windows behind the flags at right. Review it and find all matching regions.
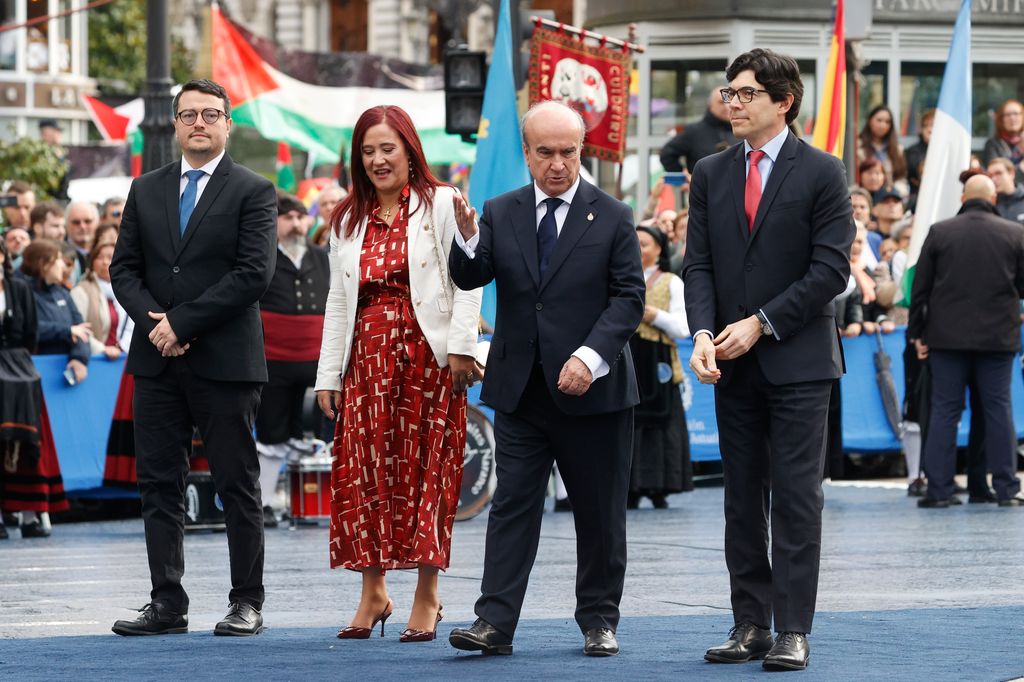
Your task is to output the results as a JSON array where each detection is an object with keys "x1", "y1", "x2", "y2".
[{"x1": 585, "y1": 0, "x2": 1024, "y2": 206}]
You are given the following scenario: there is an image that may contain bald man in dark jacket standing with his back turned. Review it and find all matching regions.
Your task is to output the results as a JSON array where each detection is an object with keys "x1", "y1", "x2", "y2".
[{"x1": 907, "y1": 175, "x2": 1024, "y2": 509}]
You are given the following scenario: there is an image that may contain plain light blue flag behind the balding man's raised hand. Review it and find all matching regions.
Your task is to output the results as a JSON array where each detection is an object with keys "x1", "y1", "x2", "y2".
[{"x1": 469, "y1": 0, "x2": 529, "y2": 325}]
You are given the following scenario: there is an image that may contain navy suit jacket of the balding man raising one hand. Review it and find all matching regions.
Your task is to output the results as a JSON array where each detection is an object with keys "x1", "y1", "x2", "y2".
[{"x1": 449, "y1": 180, "x2": 644, "y2": 415}]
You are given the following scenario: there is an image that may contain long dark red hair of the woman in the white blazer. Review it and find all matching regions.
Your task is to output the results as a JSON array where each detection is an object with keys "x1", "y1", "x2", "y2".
[{"x1": 331, "y1": 104, "x2": 446, "y2": 237}]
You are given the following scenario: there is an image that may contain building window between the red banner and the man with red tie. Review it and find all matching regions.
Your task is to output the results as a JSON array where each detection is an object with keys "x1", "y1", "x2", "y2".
[{"x1": 647, "y1": 59, "x2": 728, "y2": 136}]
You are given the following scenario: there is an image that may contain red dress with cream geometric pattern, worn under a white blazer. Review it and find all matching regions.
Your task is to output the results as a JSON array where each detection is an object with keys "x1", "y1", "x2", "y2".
[{"x1": 330, "y1": 187, "x2": 466, "y2": 570}]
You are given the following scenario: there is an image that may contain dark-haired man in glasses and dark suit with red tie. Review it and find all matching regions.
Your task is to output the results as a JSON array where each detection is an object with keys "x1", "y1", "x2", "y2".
[{"x1": 683, "y1": 49, "x2": 855, "y2": 670}]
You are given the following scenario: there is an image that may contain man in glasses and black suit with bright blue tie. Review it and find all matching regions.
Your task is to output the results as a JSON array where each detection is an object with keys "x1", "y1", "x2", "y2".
[{"x1": 111, "y1": 80, "x2": 278, "y2": 635}]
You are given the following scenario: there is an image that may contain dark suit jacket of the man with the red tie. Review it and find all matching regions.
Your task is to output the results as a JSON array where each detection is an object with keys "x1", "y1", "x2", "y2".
[{"x1": 683, "y1": 133, "x2": 855, "y2": 385}]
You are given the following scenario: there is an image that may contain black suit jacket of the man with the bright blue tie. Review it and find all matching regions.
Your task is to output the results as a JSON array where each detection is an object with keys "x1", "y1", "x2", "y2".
[{"x1": 111, "y1": 154, "x2": 278, "y2": 382}]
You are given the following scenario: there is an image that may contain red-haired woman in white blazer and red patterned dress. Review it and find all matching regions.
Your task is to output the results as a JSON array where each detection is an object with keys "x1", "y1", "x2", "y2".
[{"x1": 315, "y1": 105, "x2": 482, "y2": 642}]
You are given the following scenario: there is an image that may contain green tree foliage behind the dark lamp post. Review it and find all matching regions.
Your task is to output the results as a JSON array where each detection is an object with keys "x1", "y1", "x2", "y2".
[{"x1": 89, "y1": 0, "x2": 193, "y2": 95}]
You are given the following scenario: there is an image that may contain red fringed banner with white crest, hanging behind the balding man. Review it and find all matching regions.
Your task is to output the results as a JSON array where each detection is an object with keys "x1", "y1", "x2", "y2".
[{"x1": 529, "y1": 27, "x2": 633, "y2": 163}]
